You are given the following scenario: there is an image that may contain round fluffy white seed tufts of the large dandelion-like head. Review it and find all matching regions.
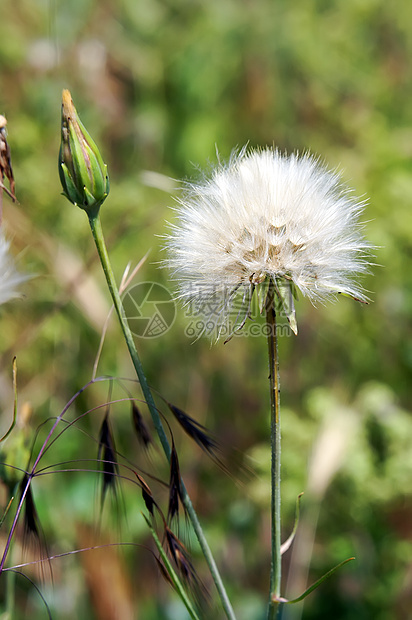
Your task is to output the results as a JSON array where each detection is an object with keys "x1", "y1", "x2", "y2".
[{"x1": 167, "y1": 148, "x2": 370, "y2": 330}]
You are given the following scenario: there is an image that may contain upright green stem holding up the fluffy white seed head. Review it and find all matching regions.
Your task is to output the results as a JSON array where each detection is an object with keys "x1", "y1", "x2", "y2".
[{"x1": 266, "y1": 280, "x2": 282, "y2": 620}]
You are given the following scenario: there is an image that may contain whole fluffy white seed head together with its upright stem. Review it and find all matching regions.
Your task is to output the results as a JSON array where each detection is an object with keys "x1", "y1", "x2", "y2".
[{"x1": 166, "y1": 147, "x2": 371, "y2": 620}]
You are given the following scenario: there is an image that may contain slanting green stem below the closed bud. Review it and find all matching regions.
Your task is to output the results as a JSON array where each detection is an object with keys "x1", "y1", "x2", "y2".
[{"x1": 89, "y1": 213, "x2": 236, "y2": 620}]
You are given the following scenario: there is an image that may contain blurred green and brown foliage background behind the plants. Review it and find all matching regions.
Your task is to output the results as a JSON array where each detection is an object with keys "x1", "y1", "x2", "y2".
[{"x1": 0, "y1": 0, "x2": 412, "y2": 620}]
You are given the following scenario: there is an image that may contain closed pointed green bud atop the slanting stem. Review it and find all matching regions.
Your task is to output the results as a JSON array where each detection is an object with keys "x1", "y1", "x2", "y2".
[{"x1": 59, "y1": 90, "x2": 109, "y2": 215}]
